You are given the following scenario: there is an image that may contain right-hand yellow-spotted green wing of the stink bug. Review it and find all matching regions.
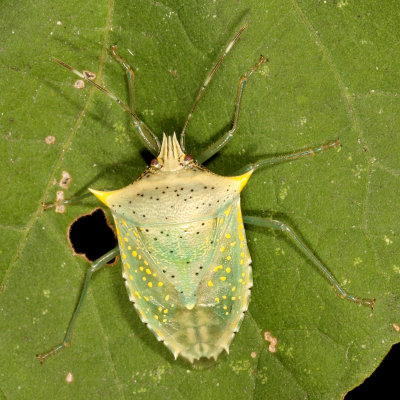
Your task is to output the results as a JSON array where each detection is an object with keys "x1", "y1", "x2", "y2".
[{"x1": 192, "y1": 198, "x2": 253, "y2": 357}]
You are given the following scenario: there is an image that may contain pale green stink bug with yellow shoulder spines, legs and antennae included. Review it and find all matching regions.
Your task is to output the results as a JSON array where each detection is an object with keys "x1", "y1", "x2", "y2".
[{"x1": 38, "y1": 26, "x2": 374, "y2": 362}]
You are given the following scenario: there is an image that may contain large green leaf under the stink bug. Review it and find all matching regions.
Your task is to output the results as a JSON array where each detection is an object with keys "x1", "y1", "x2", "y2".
[{"x1": 0, "y1": 0, "x2": 400, "y2": 400}]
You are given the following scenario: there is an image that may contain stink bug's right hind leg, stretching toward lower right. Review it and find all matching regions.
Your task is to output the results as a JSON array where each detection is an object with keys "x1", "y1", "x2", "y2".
[{"x1": 243, "y1": 216, "x2": 375, "y2": 308}]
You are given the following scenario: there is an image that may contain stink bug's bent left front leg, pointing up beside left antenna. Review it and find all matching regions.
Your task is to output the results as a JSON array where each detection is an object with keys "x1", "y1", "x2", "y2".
[{"x1": 111, "y1": 45, "x2": 161, "y2": 155}]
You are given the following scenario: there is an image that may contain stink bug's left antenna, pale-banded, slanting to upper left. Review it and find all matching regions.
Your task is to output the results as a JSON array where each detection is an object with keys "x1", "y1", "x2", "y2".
[{"x1": 53, "y1": 58, "x2": 161, "y2": 156}]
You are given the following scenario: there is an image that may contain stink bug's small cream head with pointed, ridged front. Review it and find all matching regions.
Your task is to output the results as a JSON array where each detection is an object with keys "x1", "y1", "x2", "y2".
[{"x1": 150, "y1": 133, "x2": 194, "y2": 172}]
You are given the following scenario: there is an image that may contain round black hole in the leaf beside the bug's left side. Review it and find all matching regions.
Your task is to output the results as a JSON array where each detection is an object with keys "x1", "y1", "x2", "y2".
[{"x1": 68, "y1": 208, "x2": 117, "y2": 264}]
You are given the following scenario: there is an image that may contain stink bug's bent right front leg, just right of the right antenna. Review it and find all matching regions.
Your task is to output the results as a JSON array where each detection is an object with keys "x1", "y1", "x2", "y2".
[{"x1": 197, "y1": 56, "x2": 268, "y2": 164}]
